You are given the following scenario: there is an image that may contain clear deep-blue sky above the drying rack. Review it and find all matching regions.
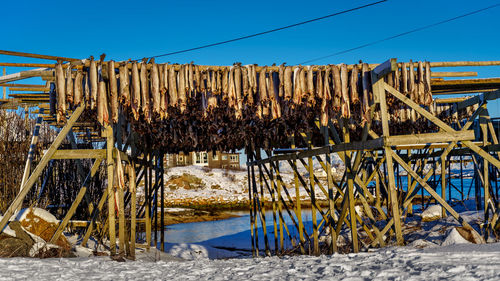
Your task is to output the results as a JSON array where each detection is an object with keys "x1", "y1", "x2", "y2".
[{"x1": 0, "y1": 0, "x2": 500, "y2": 114}]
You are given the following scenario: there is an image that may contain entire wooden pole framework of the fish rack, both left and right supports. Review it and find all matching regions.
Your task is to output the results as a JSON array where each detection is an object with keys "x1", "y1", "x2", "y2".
[{"x1": 0, "y1": 51, "x2": 500, "y2": 258}]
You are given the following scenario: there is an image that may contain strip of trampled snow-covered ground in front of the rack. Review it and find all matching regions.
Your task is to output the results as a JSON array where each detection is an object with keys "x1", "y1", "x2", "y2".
[{"x1": 0, "y1": 243, "x2": 500, "y2": 280}]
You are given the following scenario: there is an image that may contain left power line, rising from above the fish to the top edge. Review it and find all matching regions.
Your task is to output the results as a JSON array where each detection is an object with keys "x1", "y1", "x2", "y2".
[{"x1": 141, "y1": 0, "x2": 388, "y2": 58}]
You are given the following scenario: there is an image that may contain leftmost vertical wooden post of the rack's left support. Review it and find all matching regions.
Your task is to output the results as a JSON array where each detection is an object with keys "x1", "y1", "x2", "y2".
[{"x1": 105, "y1": 125, "x2": 116, "y2": 256}]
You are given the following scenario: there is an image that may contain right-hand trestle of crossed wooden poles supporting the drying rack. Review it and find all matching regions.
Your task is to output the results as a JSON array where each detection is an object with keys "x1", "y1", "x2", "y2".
[{"x1": 247, "y1": 59, "x2": 500, "y2": 256}]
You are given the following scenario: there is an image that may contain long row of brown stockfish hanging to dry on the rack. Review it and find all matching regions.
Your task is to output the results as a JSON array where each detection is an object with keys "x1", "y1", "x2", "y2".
[{"x1": 55, "y1": 57, "x2": 469, "y2": 152}]
